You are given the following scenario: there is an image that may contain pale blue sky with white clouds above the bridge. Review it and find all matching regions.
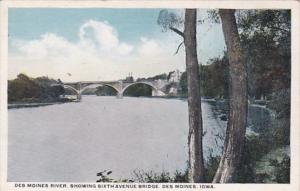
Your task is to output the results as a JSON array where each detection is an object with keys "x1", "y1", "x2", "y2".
[{"x1": 8, "y1": 8, "x2": 225, "y2": 82}]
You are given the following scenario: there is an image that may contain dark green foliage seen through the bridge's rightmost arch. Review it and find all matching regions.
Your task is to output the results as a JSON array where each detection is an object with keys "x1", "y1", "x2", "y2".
[{"x1": 124, "y1": 84, "x2": 152, "y2": 97}]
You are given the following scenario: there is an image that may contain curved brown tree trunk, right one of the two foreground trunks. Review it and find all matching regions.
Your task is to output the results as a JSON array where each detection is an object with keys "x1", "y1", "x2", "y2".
[{"x1": 213, "y1": 9, "x2": 247, "y2": 183}]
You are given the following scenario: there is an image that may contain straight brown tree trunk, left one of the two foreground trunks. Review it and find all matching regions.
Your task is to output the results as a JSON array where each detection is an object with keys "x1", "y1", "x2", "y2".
[{"x1": 184, "y1": 9, "x2": 204, "y2": 182}]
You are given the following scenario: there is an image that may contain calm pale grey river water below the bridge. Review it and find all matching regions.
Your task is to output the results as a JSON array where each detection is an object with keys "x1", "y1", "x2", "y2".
[{"x1": 8, "y1": 96, "x2": 226, "y2": 182}]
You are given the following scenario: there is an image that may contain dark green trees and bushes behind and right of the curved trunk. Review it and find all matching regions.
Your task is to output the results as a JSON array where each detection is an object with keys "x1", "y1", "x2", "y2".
[{"x1": 201, "y1": 10, "x2": 291, "y2": 183}]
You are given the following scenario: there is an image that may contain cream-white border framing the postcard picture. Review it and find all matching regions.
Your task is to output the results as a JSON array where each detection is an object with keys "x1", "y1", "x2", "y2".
[{"x1": 0, "y1": 0, "x2": 300, "y2": 191}]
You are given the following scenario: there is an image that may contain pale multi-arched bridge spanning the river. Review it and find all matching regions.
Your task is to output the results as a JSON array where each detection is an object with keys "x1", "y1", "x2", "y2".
[{"x1": 56, "y1": 80, "x2": 169, "y2": 100}]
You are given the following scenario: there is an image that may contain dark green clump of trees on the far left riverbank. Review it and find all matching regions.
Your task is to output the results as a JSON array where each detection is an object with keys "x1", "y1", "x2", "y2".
[{"x1": 8, "y1": 74, "x2": 64, "y2": 103}]
